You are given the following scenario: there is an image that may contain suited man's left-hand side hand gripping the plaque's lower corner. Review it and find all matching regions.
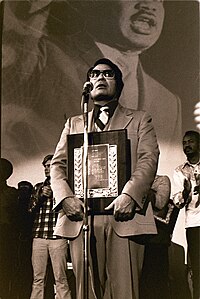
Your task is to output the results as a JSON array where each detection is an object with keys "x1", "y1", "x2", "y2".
[{"x1": 62, "y1": 196, "x2": 83, "y2": 221}]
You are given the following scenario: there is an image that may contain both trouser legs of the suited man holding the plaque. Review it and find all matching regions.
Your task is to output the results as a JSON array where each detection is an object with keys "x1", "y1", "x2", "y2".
[{"x1": 70, "y1": 216, "x2": 144, "y2": 299}]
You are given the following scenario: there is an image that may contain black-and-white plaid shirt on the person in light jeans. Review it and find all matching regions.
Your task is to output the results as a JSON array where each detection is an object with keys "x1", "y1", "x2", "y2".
[{"x1": 29, "y1": 179, "x2": 58, "y2": 239}]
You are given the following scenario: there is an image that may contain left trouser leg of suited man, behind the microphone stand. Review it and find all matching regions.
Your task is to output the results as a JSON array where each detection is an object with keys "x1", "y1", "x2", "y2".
[{"x1": 70, "y1": 216, "x2": 106, "y2": 299}]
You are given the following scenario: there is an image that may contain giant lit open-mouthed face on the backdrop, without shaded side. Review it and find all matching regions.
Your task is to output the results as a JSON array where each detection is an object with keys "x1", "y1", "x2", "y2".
[{"x1": 116, "y1": 0, "x2": 164, "y2": 51}]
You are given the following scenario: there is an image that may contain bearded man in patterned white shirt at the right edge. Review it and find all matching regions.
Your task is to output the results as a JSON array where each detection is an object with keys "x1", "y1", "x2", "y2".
[{"x1": 173, "y1": 131, "x2": 200, "y2": 299}]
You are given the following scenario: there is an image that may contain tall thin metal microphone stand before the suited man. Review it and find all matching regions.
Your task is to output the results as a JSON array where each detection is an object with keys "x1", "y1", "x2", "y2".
[{"x1": 82, "y1": 93, "x2": 89, "y2": 299}]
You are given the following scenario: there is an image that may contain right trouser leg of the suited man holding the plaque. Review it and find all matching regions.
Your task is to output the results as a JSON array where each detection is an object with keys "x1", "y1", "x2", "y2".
[{"x1": 104, "y1": 226, "x2": 144, "y2": 299}]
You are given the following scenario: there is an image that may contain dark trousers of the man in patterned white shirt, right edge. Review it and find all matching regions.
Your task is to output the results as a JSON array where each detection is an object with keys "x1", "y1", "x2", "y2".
[{"x1": 186, "y1": 227, "x2": 200, "y2": 299}]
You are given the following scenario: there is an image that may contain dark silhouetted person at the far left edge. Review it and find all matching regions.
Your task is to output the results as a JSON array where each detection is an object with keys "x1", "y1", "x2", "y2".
[{"x1": 0, "y1": 158, "x2": 19, "y2": 299}]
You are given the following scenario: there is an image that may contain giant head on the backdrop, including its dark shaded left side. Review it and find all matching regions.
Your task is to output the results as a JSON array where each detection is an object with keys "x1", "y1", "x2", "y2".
[{"x1": 73, "y1": 0, "x2": 164, "y2": 52}]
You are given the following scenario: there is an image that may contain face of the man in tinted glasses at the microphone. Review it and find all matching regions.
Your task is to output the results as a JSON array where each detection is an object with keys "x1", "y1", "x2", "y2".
[{"x1": 90, "y1": 64, "x2": 116, "y2": 103}]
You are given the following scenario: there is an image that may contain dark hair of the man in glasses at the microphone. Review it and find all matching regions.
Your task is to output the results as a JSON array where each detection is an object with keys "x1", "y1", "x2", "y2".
[{"x1": 87, "y1": 58, "x2": 124, "y2": 98}]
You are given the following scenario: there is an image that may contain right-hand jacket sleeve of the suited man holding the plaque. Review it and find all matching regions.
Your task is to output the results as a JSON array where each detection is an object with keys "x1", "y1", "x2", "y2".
[{"x1": 122, "y1": 112, "x2": 159, "y2": 208}]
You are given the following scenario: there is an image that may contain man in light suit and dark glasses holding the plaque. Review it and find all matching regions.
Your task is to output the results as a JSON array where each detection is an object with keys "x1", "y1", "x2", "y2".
[{"x1": 51, "y1": 58, "x2": 159, "y2": 299}]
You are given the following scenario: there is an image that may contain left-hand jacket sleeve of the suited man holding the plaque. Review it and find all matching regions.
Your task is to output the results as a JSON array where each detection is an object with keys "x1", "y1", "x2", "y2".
[{"x1": 51, "y1": 118, "x2": 74, "y2": 208}]
